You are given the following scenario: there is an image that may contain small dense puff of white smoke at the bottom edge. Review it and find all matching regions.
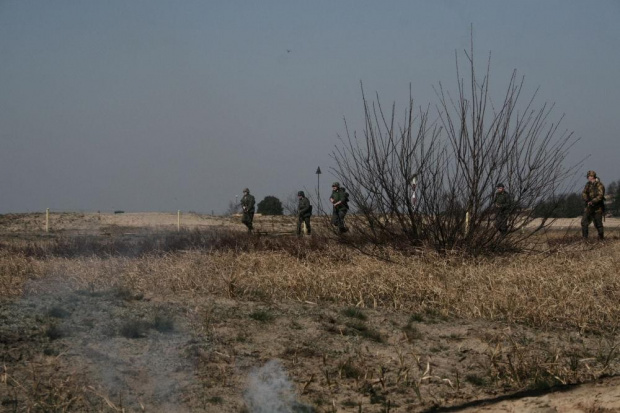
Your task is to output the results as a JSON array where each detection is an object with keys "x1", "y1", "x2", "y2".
[{"x1": 244, "y1": 360, "x2": 312, "y2": 413}]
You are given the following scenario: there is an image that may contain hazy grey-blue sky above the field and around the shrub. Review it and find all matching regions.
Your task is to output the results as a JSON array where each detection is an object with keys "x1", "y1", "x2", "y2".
[{"x1": 0, "y1": 0, "x2": 620, "y2": 213}]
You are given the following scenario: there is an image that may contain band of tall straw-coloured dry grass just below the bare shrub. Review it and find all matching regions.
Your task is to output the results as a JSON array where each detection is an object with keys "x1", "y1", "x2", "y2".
[{"x1": 0, "y1": 233, "x2": 620, "y2": 331}]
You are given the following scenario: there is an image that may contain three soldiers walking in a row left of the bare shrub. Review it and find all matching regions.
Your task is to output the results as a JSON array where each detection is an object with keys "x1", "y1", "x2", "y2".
[{"x1": 241, "y1": 182, "x2": 349, "y2": 236}]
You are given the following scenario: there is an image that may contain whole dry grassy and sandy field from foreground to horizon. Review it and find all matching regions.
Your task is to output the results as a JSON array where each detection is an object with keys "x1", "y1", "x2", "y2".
[{"x1": 0, "y1": 213, "x2": 620, "y2": 412}]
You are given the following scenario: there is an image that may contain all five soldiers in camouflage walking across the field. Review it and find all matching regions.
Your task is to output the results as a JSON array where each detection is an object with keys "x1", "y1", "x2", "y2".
[{"x1": 241, "y1": 171, "x2": 605, "y2": 240}]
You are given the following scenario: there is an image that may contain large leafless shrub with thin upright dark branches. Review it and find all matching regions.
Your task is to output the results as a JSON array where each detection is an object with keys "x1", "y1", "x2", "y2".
[{"x1": 332, "y1": 40, "x2": 576, "y2": 252}]
